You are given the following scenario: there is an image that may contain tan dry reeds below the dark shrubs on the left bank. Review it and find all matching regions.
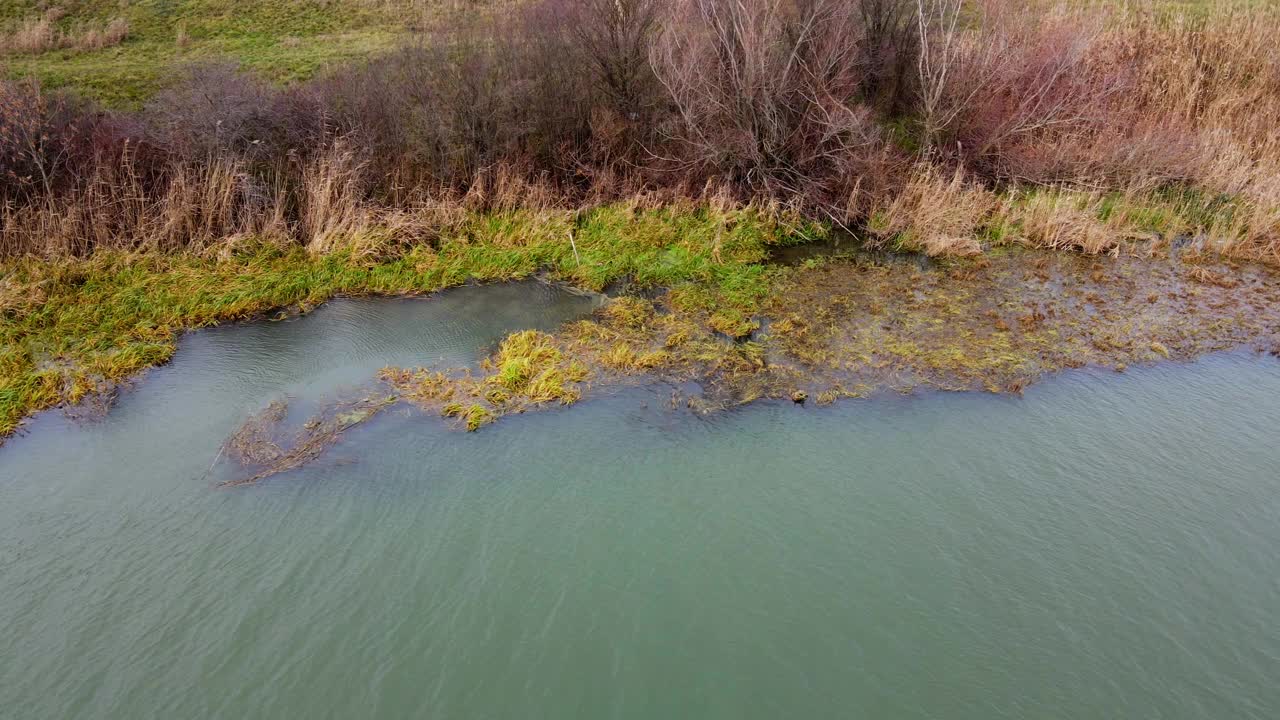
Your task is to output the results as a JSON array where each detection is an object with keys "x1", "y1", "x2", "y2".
[{"x1": 0, "y1": 145, "x2": 450, "y2": 258}]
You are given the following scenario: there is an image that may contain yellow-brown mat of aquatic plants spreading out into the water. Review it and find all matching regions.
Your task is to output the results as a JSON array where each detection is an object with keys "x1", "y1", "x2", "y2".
[{"x1": 209, "y1": 250, "x2": 1280, "y2": 486}]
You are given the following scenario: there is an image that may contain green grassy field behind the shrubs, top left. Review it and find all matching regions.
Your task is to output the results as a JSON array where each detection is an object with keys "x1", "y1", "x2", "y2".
[{"x1": 0, "y1": 0, "x2": 445, "y2": 108}]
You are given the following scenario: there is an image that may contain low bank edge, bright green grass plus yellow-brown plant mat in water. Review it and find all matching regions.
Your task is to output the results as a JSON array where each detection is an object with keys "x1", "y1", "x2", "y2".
[{"x1": 0, "y1": 198, "x2": 1280, "y2": 443}]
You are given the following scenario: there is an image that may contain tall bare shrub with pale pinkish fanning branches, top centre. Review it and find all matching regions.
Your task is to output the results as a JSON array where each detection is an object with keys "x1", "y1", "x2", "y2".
[{"x1": 654, "y1": 0, "x2": 896, "y2": 196}]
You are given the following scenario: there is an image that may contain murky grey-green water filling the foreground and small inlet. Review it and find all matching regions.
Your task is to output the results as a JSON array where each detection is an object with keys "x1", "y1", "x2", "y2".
[{"x1": 0, "y1": 286, "x2": 1280, "y2": 720}]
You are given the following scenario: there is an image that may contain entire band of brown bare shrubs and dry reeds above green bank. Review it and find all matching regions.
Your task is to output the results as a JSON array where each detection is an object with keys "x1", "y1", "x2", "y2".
[{"x1": 0, "y1": 0, "x2": 1280, "y2": 261}]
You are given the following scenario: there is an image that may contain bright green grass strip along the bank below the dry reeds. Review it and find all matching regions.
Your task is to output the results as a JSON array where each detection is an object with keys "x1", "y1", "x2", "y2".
[{"x1": 0, "y1": 205, "x2": 823, "y2": 437}]
